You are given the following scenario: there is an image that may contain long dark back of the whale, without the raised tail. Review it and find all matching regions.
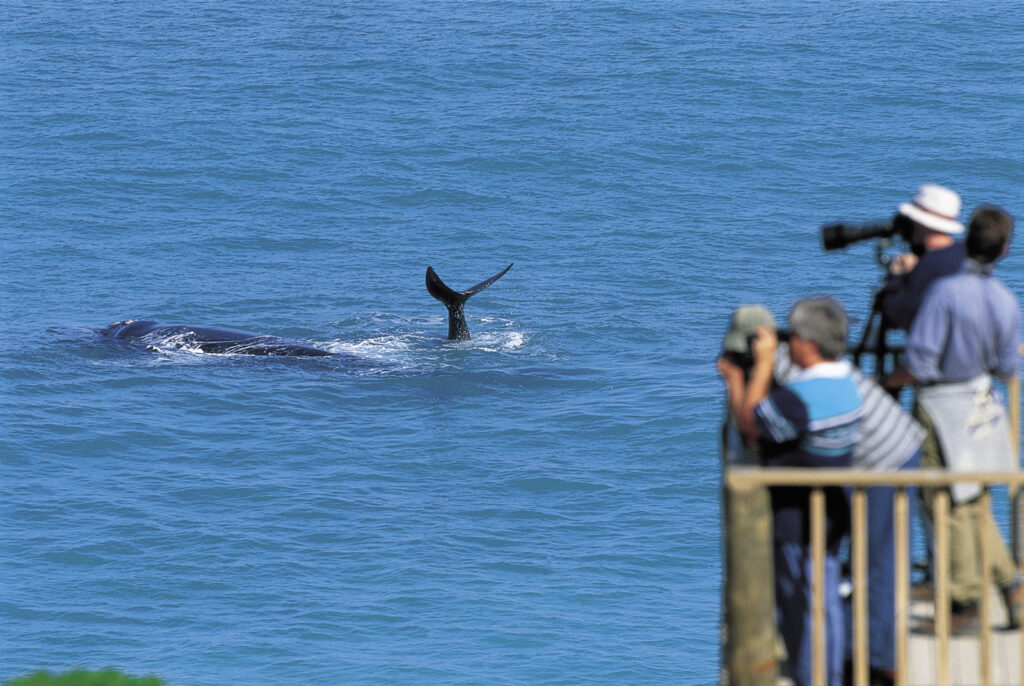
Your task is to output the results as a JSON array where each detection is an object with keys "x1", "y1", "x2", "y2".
[{"x1": 99, "y1": 319, "x2": 335, "y2": 357}]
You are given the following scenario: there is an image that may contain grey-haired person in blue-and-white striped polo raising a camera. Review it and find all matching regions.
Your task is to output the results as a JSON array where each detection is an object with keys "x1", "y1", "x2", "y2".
[{"x1": 718, "y1": 298, "x2": 861, "y2": 686}]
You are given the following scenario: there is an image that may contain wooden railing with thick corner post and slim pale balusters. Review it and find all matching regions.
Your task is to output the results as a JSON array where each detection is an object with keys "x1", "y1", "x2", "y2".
[{"x1": 725, "y1": 467, "x2": 1024, "y2": 686}]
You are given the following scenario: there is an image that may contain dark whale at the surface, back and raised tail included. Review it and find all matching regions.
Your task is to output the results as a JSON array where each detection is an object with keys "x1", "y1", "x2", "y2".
[{"x1": 97, "y1": 264, "x2": 512, "y2": 357}]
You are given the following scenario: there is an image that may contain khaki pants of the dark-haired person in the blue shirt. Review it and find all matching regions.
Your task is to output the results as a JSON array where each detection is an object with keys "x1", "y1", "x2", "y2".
[{"x1": 913, "y1": 405, "x2": 1017, "y2": 604}]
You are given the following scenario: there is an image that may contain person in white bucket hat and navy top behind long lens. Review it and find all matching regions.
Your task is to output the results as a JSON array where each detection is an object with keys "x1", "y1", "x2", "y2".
[{"x1": 879, "y1": 183, "x2": 964, "y2": 330}]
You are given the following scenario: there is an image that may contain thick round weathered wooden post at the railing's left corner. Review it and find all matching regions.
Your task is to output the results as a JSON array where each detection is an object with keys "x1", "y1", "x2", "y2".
[{"x1": 723, "y1": 484, "x2": 778, "y2": 686}]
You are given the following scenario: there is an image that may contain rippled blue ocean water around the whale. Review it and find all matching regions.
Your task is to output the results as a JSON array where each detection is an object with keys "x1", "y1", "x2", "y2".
[{"x1": 0, "y1": 0, "x2": 1024, "y2": 686}]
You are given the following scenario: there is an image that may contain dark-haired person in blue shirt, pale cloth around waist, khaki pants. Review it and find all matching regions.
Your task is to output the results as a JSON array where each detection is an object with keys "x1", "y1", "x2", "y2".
[{"x1": 901, "y1": 207, "x2": 1022, "y2": 633}]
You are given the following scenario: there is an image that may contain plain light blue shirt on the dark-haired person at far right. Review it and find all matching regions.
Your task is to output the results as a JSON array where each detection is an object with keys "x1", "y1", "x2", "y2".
[{"x1": 906, "y1": 259, "x2": 1021, "y2": 384}]
